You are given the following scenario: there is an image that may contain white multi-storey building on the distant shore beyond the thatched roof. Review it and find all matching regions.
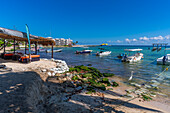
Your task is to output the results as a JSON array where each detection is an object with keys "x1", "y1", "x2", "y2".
[{"x1": 54, "y1": 38, "x2": 73, "y2": 46}]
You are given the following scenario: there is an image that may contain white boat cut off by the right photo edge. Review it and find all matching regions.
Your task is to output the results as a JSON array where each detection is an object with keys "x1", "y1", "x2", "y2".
[{"x1": 157, "y1": 54, "x2": 170, "y2": 65}]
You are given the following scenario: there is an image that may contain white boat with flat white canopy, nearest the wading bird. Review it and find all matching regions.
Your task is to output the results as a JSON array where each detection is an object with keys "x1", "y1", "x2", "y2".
[{"x1": 122, "y1": 49, "x2": 143, "y2": 62}]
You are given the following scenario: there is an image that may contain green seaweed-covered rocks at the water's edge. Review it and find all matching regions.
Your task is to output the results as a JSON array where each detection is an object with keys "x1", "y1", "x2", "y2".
[{"x1": 69, "y1": 65, "x2": 119, "y2": 94}]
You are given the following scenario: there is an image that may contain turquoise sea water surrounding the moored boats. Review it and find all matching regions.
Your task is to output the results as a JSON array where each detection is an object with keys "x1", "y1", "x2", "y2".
[{"x1": 39, "y1": 46, "x2": 170, "y2": 95}]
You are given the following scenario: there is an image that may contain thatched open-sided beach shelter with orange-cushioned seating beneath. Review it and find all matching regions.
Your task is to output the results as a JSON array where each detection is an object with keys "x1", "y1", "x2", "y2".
[{"x1": 0, "y1": 27, "x2": 55, "y2": 63}]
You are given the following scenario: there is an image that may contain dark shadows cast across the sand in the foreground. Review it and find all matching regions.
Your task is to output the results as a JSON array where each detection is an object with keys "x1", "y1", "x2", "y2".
[{"x1": 0, "y1": 71, "x2": 160, "y2": 113}]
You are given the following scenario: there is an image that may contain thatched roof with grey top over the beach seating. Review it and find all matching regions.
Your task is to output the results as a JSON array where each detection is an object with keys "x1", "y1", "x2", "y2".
[{"x1": 0, "y1": 27, "x2": 55, "y2": 45}]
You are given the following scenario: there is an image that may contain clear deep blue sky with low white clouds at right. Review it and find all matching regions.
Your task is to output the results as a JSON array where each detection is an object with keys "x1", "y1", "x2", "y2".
[{"x1": 0, "y1": 0, "x2": 170, "y2": 44}]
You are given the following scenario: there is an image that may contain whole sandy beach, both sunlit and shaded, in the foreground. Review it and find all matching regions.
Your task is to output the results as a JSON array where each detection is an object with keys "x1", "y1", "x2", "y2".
[{"x1": 0, "y1": 59, "x2": 170, "y2": 113}]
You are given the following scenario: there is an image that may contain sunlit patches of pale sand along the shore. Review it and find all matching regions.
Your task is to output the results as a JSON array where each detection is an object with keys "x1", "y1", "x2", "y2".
[{"x1": 0, "y1": 59, "x2": 170, "y2": 113}]
